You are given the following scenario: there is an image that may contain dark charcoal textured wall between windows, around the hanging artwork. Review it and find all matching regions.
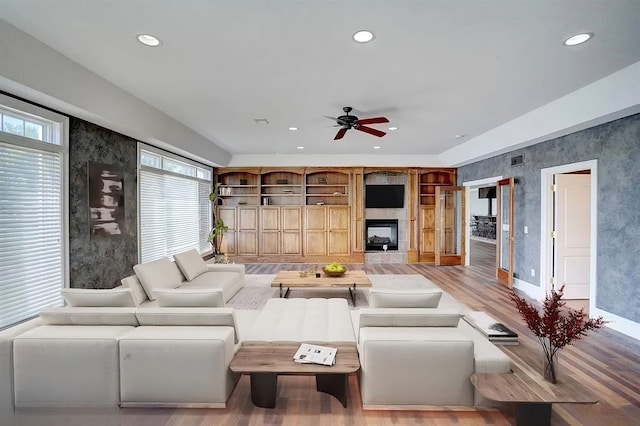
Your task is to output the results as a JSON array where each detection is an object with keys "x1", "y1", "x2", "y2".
[{"x1": 69, "y1": 117, "x2": 138, "y2": 288}]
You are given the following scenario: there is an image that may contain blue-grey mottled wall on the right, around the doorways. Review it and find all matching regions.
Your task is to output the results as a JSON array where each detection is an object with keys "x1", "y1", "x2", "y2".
[{"x1": 458, "y1": 114, "x2": 640, "y2": 322}]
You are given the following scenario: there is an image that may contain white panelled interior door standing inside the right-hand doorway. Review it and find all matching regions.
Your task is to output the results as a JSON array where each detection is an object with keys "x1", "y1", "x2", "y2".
[{"x1": 554, "y1": 174, "x2": 591, "y2": 299}]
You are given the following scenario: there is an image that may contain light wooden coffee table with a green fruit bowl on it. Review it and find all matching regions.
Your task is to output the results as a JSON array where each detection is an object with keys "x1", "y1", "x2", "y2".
[{"x1": 271, "y1": 271, "x2": 371, "y2": 306}]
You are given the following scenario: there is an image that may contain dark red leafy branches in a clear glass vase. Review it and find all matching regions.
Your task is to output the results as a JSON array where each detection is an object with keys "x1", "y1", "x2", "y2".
[{"x1": 511, "y1": 285, "x2": 609, "y2": 383}]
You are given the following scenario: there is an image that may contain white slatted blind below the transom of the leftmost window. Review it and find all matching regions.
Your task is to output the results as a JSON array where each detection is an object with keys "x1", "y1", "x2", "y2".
[{"x1": 0, "y1": 142, "x2": 65, "y2": 329}]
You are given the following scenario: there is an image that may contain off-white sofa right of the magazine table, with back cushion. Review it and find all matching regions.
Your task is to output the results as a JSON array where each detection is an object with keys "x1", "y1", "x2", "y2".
[{"x1": 352, "y1": 290, "x2": 511, "y2": 409}]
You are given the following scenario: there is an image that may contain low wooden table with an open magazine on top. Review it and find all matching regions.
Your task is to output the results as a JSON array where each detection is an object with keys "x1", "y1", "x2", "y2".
[{"x1": 230, "y1": 344, "x2": 360, "y2": 408}]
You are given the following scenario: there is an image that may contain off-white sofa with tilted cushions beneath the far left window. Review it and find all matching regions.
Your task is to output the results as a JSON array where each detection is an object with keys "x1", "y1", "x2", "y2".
[{"x1": 122, "y1": 250, "x2": 245, "y2": 307}]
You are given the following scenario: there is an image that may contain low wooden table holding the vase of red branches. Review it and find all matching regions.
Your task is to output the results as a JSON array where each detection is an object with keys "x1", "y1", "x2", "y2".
[{"x1": 471, "y1": 369, "x2": 598, "y2": 426}]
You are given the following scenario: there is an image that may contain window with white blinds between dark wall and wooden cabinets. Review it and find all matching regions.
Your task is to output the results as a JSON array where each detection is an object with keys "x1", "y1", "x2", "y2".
[{"x1": 138, "y1": 144, "x2": 213, "y2": 263}]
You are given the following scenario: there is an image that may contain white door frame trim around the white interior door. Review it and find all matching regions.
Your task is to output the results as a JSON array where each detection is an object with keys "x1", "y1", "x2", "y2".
[{"x1": 540, "y1": 160, "x2": 598, "y2": 312}]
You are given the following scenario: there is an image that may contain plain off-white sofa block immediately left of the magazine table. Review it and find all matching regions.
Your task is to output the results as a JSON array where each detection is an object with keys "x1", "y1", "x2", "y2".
[{"x1": 120, "y1": 326, "x2": 239, "y2": 408}]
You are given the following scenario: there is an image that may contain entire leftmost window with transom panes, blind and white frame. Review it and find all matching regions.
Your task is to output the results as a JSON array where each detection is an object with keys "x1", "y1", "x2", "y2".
[{"x1": 0, "y1": 95, "x2": 68, "y2": 329}]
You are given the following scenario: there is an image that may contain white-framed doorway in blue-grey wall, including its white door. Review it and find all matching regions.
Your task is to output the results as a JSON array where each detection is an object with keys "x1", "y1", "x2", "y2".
[{"x1": 540, "y1": 160, "x2": 597, "y2": 312}]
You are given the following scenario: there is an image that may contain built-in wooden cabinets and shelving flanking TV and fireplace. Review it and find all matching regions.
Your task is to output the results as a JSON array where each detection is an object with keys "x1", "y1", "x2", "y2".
[{"x1": 216, "y1": 167, "x2": 457, "y2": 263}]
